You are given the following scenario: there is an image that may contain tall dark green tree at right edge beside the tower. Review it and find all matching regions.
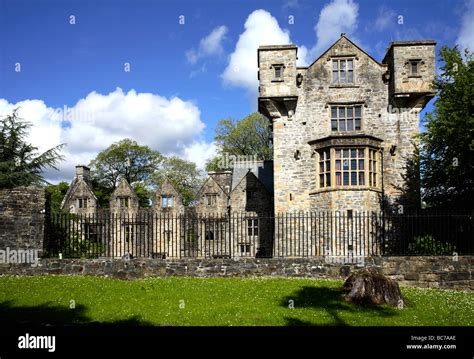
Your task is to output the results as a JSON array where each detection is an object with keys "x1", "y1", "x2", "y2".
[{"x1": 420, "y1": 47, "x2": 474, "y2": 208}]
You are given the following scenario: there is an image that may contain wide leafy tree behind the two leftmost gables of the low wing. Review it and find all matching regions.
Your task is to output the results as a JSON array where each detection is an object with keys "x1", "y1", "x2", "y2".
[{"x1": 91, "y1": 138, "x2": 163, "y2": 190}]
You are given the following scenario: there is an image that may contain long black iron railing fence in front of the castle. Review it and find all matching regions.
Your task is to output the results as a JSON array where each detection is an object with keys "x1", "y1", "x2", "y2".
[{"x1": 45, "y1": 210, "x2": 474, "y2": 261}]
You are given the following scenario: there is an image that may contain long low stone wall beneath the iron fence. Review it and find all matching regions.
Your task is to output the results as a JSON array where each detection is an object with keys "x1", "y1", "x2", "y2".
[{"x1": 0, "y1": 256, "x2": 474, "y2": 290}]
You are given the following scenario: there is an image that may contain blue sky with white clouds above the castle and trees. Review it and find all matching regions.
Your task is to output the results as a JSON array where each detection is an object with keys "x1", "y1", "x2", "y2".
[{"x1": 0, "y1": 0, "x2": 474, "y2": 180}]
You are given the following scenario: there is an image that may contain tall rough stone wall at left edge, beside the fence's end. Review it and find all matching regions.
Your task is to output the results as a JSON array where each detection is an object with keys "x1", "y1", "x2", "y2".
[{"x1": 0, "y1": 187, "x2": 46, "y2": 250}]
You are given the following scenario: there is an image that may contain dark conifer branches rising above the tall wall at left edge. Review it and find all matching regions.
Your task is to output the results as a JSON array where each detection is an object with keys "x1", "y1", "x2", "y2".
[{"x1": 0, "y1": 109, "x2": 64, "y2": 188}]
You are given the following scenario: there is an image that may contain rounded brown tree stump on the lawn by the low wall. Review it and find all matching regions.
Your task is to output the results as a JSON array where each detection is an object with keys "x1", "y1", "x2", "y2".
[{"x1": 343, "y1": 268, "x2": 404, "y2": 308}]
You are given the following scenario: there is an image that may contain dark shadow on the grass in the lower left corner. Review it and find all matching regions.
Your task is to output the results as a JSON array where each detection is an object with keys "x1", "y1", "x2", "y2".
[{"x1": 0, "y1": 301, "x2": 153, "y2": 328}]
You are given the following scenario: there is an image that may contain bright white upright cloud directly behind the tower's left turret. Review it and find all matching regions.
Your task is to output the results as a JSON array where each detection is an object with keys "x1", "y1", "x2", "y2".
[{"x1": 221, "y1": 9, "x2": 308, "y2": 94}]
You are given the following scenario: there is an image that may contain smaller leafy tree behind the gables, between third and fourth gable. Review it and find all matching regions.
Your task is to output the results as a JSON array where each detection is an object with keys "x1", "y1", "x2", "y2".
[{"x1": 151, "y1": 157, "x2": 203, "y2": 205}]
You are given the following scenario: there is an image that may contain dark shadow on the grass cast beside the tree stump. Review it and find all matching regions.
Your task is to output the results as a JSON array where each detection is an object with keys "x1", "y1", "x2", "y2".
[{"x1": 281, "y1": 286, "x2": 397, "y2": 326}]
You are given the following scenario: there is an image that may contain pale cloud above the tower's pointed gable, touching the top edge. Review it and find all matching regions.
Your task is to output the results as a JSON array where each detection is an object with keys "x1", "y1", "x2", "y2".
[{"x1": 310, "y1": 0, "x2": 359, "y2": 58}]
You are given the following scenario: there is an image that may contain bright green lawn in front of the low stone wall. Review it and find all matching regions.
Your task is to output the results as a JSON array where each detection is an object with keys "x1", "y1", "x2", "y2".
[{"x1": 0, "y1": 276, "x2": 474, "y2": 326}]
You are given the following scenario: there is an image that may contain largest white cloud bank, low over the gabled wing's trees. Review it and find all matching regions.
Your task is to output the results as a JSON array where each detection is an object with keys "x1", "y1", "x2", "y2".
[{"x1": 0, "y1": 88, "x2": 212, "y2": 181}]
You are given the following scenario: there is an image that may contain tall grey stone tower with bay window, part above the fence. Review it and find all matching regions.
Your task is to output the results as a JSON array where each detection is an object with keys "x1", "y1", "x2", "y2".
[{"x1": 258, "y1": 34, "x2": 435, "y2": 213}]
